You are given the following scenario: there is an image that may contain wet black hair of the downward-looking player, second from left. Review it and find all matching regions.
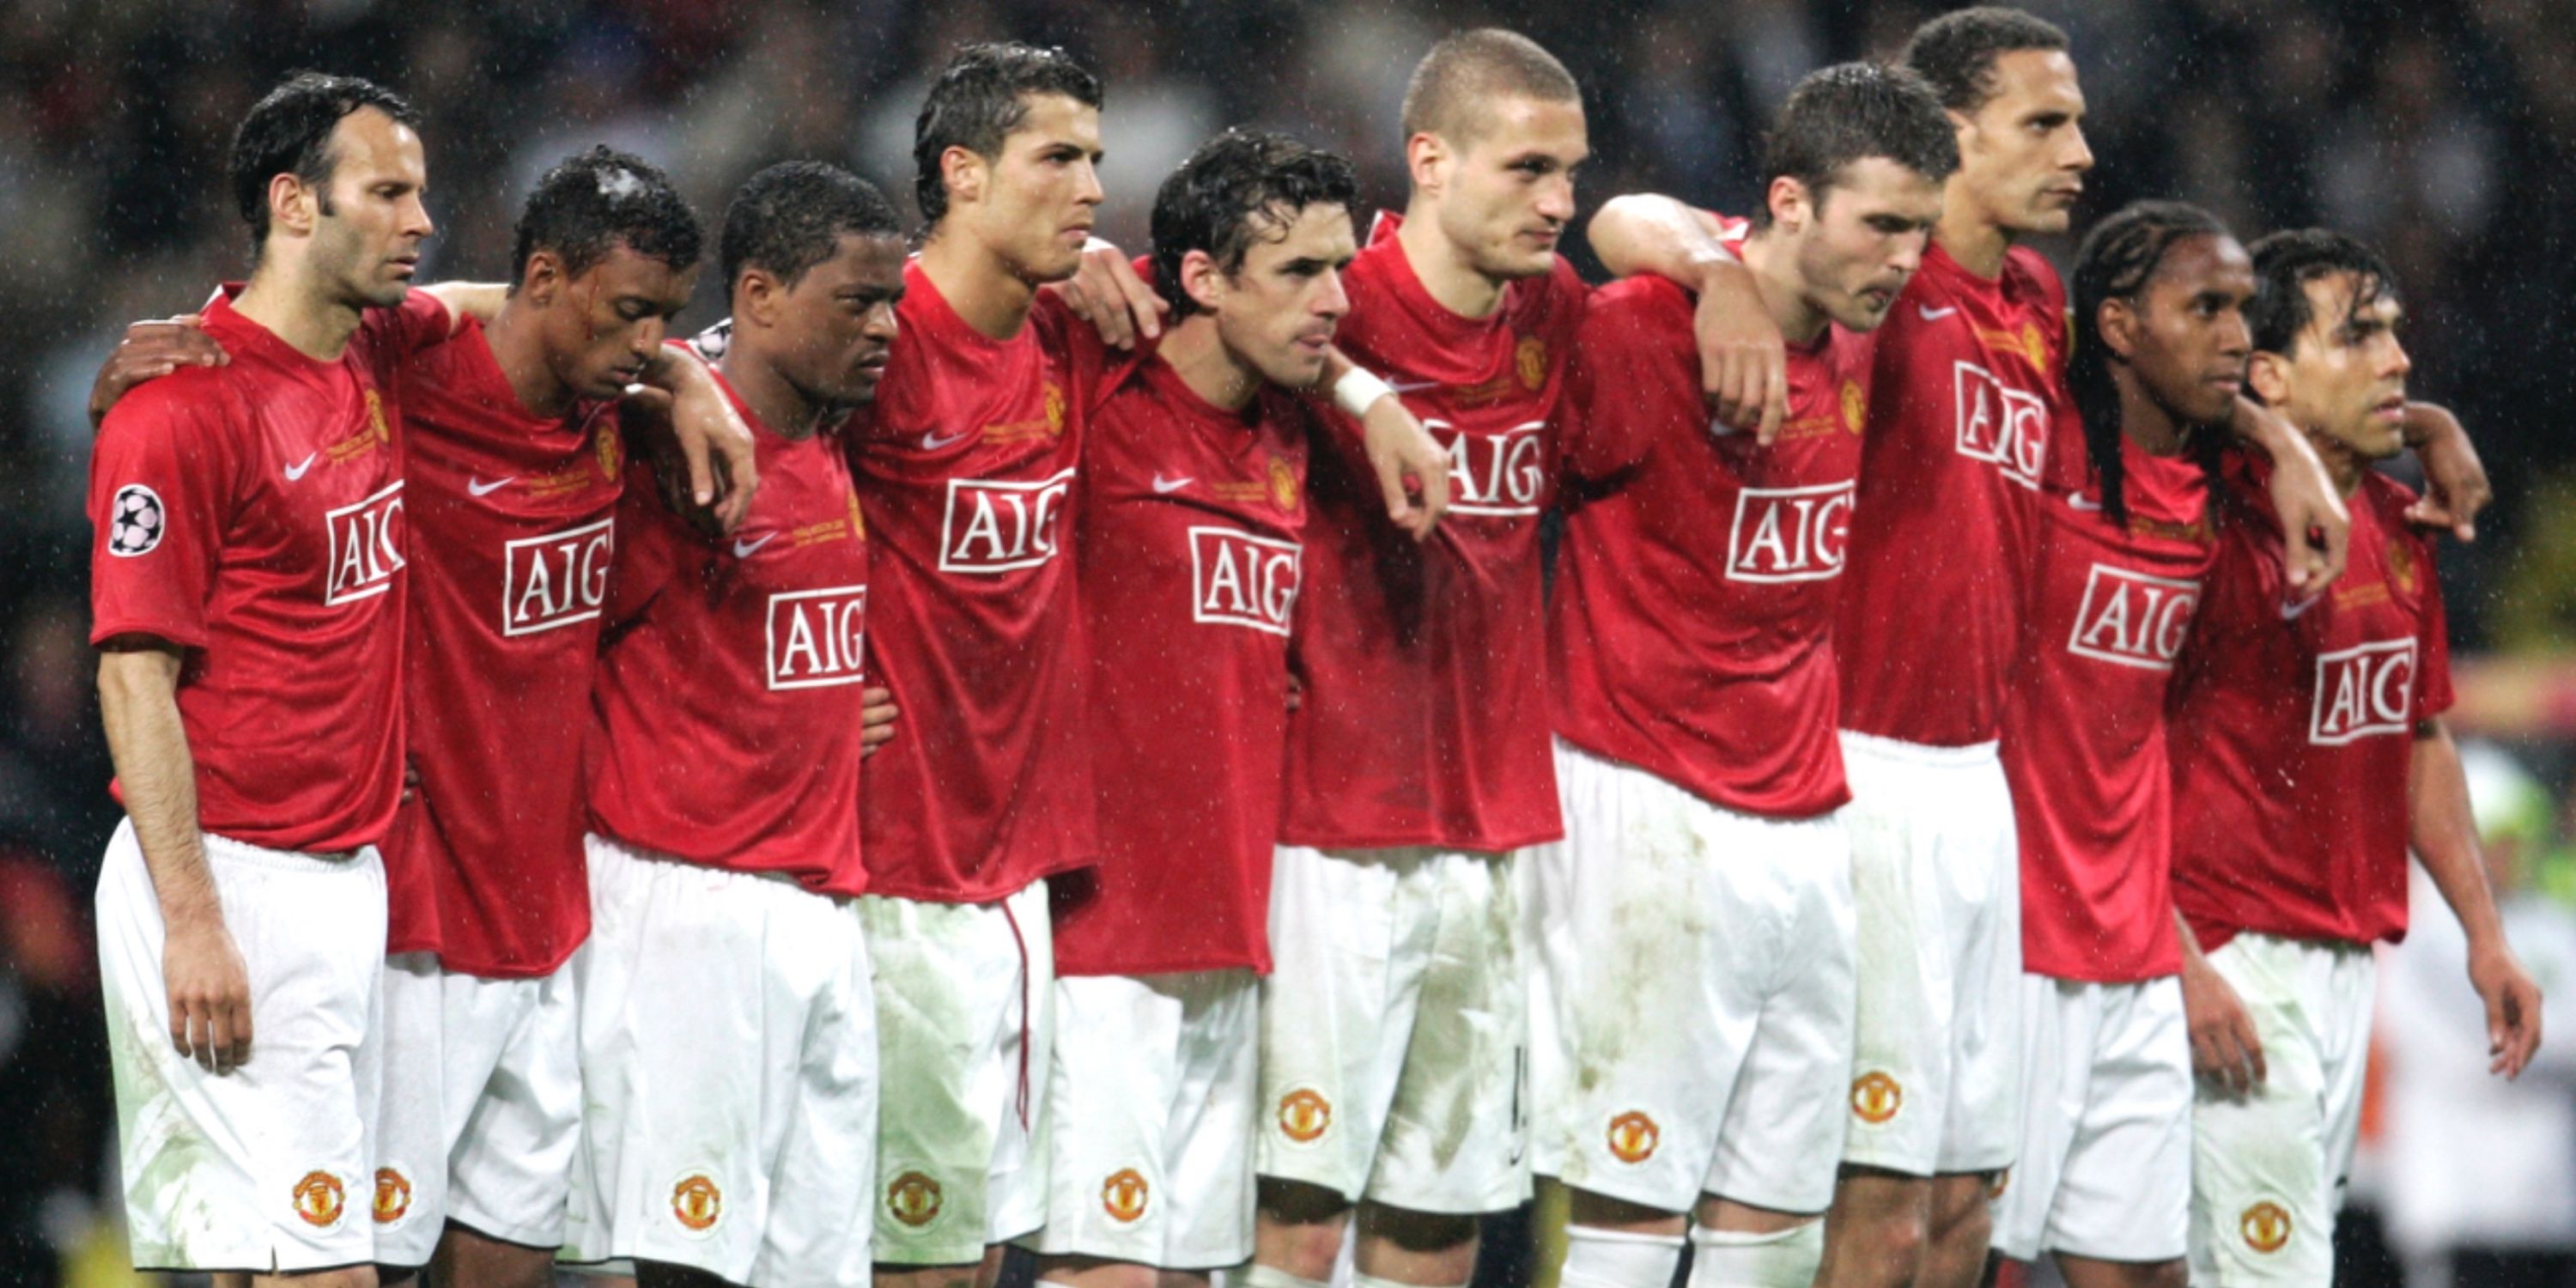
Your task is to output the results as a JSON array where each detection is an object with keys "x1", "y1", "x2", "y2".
[{"x1": 510, "y1": 147, "x2": 706, "y2": 291}]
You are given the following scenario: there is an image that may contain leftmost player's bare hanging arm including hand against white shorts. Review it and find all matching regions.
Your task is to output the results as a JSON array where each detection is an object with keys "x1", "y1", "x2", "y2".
[{"x1": 98, "y1": 636, "x2": 250, "y2": 1072}]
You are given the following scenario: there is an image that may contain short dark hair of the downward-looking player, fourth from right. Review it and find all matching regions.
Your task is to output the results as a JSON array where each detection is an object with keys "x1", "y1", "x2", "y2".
[{"x1": 1754, "y1": 62, "x2": 1958, "y2": 227}]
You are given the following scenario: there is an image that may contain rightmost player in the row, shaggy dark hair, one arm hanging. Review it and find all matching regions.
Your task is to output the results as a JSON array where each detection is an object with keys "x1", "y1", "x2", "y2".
[{"x1": 2169, "y1": 229, "x2": 2540, "y2": 1285}]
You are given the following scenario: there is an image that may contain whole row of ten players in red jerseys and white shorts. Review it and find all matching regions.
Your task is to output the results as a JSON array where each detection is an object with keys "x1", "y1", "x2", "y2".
[{"x1": 93, "y1": 10, "x2": 2537, "y2": 1288}]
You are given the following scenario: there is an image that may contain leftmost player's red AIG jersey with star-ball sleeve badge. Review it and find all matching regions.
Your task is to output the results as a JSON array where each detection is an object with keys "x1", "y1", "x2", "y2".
[{"x1": 90, "y1": 286, "x2": 448, "y2": 853}]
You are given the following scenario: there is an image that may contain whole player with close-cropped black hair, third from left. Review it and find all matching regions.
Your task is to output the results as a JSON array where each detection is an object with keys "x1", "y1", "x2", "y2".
[{"x1": 564, "y1": 162, "x2": 904, "y2": 1288}]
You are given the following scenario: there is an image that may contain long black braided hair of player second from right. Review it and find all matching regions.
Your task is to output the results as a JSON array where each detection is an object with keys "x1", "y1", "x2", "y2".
[{"x1": 2066, "y1": 201, "x2": 2228, "y2": 526}]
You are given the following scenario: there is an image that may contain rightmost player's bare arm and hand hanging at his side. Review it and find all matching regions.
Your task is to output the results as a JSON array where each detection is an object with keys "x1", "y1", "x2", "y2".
[{"x1": 2406, "y1": 719, "x2": 2540, "y2": 1077}]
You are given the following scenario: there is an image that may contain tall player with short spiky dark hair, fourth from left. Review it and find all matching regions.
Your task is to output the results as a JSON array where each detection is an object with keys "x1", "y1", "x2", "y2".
[{"x1": 850, "y1": 44, "x2": 1440, "y2": 1288}]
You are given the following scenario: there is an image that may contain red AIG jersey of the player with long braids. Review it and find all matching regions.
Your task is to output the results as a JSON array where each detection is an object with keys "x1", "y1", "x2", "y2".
[{"x1": 2004, "y1": 440, "x2": 2218, "y2": 984}]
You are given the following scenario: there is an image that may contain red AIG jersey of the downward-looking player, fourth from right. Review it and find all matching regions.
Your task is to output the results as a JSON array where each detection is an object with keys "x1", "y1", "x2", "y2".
[{"x1": 1551, "y1": 266, "x2": 1870, "y2": 819}]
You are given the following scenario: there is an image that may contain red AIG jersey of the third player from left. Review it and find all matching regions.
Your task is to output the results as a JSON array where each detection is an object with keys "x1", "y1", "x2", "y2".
[{"x1": 587, "y1": 376, "x2": 871, "y2": 894}]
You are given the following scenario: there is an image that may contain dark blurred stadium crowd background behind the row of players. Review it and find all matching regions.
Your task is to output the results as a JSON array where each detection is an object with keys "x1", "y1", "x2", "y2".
[{"x1": 0, "y1": 0, "x2": 2576, "y2": 1285}]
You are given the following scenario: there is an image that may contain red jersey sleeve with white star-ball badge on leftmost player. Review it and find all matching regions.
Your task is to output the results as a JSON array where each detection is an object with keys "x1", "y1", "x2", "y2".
[{"x1": 90, "y1": 374, "x2": 240, "y2": 649}]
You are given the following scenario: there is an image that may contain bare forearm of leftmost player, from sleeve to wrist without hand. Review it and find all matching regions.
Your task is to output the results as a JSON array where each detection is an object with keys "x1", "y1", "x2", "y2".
[{"x1": 98, "y1": 649, "x2": 224, "y2": 922}]
